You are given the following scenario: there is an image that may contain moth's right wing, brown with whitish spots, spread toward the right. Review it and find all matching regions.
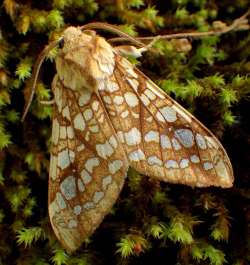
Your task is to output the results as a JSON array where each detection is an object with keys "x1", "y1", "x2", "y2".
[{"x1": 100, "y1": 55, "x2": 233, "y2": 187}]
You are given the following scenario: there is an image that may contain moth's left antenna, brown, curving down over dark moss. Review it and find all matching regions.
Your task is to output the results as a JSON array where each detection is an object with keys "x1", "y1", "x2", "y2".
[{"x1": 21, "y1": 38, "x2": 63, "y2": 122}]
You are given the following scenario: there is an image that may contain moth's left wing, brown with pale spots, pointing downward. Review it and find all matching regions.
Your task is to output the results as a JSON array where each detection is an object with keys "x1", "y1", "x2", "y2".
[{"x1": 49, "y1": 75, "x2": 128, "y2": 252}]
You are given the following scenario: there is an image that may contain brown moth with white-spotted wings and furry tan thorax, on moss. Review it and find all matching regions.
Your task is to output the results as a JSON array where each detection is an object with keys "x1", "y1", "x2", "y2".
[{"x1": 22, "y1": 24, "x2": 233, "y2": 252}]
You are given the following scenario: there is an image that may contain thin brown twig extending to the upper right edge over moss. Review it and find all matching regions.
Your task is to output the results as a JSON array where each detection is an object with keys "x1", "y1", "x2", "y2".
[{"x1": 109, "y1": 9, "x2": 250, "y2": 43}]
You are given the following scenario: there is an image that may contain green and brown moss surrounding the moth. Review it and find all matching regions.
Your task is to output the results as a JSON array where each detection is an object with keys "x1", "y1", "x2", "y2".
[{"x1": 0, "y1": 0, "x2": 250, "y2": 265}]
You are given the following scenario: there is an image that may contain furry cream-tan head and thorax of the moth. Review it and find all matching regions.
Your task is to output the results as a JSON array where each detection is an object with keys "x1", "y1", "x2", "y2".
[{"x1": 56, "y1": 27, "x2": 115, "y2": 90}]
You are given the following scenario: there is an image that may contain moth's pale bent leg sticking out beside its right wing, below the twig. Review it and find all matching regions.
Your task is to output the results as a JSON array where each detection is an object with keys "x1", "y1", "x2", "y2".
[{"x1": 115, "y1": 36, "x2": 161, "y2": 58}]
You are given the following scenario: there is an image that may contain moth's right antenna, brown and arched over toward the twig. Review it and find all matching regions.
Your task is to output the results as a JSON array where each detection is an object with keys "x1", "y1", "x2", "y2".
[{"x1": 79, "y1": 22, "x2": 145, "y2": 47}]
